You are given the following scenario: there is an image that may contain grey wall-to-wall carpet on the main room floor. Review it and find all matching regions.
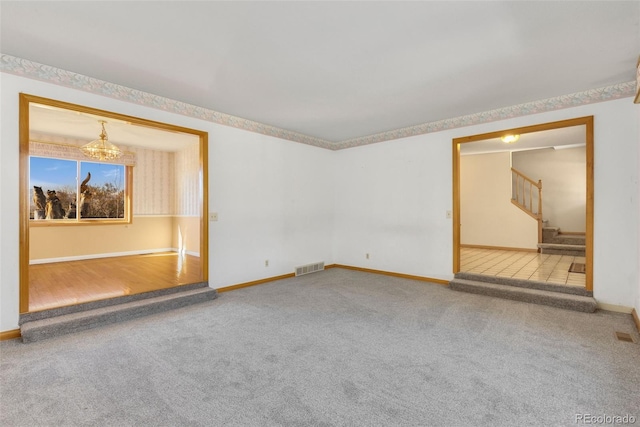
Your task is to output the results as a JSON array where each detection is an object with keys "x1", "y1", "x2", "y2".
[{"x1": 0, "y1": 269, "x2": 640, "y2": 427}]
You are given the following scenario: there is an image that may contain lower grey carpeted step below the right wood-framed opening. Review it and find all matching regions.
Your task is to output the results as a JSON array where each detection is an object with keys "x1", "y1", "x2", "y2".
[{"x1": 449, "y1": 278, "x2": 596, "y2": 313}]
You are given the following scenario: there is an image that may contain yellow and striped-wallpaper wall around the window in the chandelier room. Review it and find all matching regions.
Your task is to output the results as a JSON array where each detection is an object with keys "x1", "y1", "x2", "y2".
[{"x1": 29, "y1": 140, "x2": 200, "y2": 262}]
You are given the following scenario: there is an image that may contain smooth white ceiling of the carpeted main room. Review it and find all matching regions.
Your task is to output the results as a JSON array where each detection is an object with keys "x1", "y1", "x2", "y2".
[{"x1": 0, "y1": 1, "x2": 640, "y2": 142}]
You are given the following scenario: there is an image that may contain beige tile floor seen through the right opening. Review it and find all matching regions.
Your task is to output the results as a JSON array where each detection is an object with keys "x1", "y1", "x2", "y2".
[{"x1": 460, "y1": 248, "x2": 585, "y2": 287}]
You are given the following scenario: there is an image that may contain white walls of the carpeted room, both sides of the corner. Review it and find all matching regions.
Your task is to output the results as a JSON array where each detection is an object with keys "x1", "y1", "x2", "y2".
[{"x1": 0, "y1": 73, "x2": 640, "y2": 331}]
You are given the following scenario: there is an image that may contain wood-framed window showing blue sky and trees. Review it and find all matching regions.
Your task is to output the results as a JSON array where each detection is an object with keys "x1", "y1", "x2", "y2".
[{"x1": 29, "y1": 156, "x2": 131, "y2": 223}]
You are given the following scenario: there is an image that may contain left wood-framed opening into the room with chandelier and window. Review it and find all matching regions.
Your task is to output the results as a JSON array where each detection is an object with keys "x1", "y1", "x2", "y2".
[{"x1": 19, "y1": 94, "x2": 208, "y2": 314}]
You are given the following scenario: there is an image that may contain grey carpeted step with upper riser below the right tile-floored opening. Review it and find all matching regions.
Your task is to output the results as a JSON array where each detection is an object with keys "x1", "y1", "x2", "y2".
[{"x1": 449, "y1": 273, "x2": 596, "y2": 313}]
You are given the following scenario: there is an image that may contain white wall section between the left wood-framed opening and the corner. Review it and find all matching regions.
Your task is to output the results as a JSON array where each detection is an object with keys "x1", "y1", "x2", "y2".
[{"x1": 209, "y1": 126, "x2": 334, "y2": 287}]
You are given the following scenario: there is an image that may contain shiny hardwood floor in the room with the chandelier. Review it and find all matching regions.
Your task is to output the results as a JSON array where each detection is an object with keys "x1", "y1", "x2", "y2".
[{"x1": 29, "y1": 252, "x2": 202, "y2": 311}]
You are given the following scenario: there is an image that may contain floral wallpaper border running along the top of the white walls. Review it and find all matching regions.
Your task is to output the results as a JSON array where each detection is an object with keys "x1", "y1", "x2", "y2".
[{"x1": 0, "y1": 54, "x2": 636, "y2": 150}]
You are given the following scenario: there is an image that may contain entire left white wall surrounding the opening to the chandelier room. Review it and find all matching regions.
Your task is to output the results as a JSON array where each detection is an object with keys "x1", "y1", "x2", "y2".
[{"x1": 0, "y1": 73, "x2": 334, "y2": 331}]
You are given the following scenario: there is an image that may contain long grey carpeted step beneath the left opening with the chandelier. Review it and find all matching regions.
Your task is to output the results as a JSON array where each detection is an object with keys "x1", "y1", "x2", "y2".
[{"x1": 20, "y1": 287, "x2": 218, "y2": 343}]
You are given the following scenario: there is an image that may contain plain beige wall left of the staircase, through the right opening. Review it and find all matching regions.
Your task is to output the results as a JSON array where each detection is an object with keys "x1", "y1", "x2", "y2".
[{"x1": 460, "y1": 151, "x2": 538, "y2": 249}]
